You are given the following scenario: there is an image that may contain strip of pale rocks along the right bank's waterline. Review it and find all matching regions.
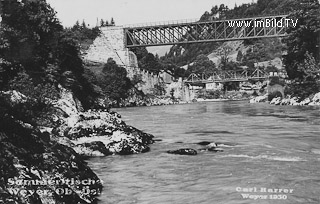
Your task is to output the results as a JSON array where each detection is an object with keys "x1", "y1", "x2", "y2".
[{"x1": 250, "y1": 92, "x2": 320, "y2": 106}]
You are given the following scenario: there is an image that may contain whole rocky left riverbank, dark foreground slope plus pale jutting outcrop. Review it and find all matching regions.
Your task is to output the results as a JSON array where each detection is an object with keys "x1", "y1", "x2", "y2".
[{"x1": 0, "y1": 88, "x2": 153, "y2": 204}]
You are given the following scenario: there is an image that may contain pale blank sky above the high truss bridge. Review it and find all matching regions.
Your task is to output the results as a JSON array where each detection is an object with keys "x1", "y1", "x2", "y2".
[{"x1": 47, "y1": 0, "x2": 256, "y2": 27}]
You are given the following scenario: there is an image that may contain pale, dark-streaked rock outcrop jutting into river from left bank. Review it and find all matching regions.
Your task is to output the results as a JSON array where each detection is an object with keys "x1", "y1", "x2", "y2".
[{"x1": 53, "y1": 98, "x2": 154, "y2": 156}]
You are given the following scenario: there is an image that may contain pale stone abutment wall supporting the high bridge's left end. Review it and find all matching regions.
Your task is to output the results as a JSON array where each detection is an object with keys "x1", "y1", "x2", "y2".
[{"x1": 84, "y1": 26, "x2": 162, "y2": 93}]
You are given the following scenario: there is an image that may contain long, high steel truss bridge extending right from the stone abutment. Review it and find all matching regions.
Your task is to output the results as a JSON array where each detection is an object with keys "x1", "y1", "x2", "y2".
[{"x1": 124, "y1": 15, "x2": 293, "y2": 48}]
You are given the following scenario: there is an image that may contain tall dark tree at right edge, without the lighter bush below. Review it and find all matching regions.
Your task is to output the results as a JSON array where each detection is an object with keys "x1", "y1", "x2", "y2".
[{"x1": 283, "y1": 0, "x2": 320, "y2": 81}]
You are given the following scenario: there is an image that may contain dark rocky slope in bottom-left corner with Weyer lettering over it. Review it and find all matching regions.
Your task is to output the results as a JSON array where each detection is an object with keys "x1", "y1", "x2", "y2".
[{"x1": 0, "y1": 116, "x2": 102, "y2": 203}]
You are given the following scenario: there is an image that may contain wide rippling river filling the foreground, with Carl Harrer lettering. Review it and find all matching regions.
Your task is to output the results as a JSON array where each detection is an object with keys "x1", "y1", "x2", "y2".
[{"x1": 88, "y1": 101, "x2": 320, "y2": 204}]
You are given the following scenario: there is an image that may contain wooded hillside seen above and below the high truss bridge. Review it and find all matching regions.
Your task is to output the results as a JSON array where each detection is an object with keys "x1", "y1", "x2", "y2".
[{"x1": 161, "y1": 0, "x2": 300, "y2": 73}]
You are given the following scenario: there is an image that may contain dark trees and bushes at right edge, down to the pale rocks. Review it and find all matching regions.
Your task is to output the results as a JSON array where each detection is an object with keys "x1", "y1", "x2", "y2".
[{"x1": 283, "y1": 0, "x2": 320, "y2": 99}]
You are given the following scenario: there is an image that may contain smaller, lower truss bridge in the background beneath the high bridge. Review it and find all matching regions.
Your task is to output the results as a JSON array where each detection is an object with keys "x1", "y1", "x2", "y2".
[{"x1": 184, "y1": 68, "x2": 269, "y2": 85}]
